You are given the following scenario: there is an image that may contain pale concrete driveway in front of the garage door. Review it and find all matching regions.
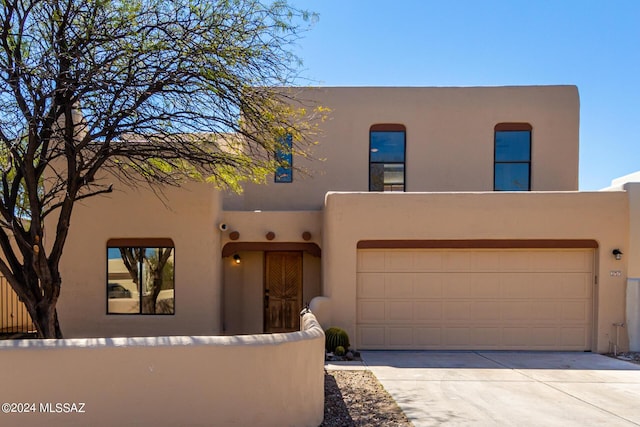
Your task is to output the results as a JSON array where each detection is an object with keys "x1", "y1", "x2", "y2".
[{"x1": 362, "y1": 351, "x2": 640, "y2": 427}]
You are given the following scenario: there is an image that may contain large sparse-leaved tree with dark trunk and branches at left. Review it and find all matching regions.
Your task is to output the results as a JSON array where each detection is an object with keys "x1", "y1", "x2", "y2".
[{"x1": 0, "y1": 0, "x2": 316, "y2": 338}]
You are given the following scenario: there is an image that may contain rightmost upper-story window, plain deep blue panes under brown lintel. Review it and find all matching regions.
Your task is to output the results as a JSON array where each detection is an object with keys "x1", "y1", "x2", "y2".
[{"x1": 493, "y1": 123, "x2": 532, "y2": 191}]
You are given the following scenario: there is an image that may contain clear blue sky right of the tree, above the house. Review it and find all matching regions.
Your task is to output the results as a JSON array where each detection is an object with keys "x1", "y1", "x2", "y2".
[{"x1": 292, "y1": 0, "x2": 640, "y2": 190}]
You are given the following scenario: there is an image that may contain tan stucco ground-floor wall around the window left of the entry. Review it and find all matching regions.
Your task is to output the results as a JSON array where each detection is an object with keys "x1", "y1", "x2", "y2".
[{"x1": 55, "y1": 184, "x2": 222, "y2": 338}]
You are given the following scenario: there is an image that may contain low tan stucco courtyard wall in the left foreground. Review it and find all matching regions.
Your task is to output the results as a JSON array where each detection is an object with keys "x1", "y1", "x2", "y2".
[{"x1": 0, "y1": 314, "x2": 324, "y2": 427}]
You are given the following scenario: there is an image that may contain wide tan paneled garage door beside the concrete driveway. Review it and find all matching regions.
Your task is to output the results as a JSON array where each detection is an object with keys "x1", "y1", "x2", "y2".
[{"x1": 356, "y1": 249, "x2": 594, "y2": 351}]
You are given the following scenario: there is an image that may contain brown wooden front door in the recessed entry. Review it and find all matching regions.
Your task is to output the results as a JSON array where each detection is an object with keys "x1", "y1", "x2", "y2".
[{"x1": 264, "y1": 252, "x2": 302, "y2": 333}]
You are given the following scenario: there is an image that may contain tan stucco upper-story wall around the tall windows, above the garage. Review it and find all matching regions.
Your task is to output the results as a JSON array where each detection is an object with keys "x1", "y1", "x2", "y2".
[{"x1": 224, "y1": 86, "x2": 580, "y2": 210}]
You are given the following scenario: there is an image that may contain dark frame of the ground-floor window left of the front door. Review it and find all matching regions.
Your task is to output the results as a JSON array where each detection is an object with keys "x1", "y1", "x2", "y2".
[{"x1": 105, "y1": 238, "x2": 176, "y2": 316}]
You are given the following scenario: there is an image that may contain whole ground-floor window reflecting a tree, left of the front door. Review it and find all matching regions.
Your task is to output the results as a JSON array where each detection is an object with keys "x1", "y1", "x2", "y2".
[{"x1": 107, "y1": 239, "x2": 175, "y2": 314}]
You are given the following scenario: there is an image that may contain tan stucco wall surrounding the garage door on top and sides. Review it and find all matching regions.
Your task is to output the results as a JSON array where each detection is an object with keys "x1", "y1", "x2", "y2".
[{"x1": 323, "y1": 192, "x2": 629, "y2": 352}]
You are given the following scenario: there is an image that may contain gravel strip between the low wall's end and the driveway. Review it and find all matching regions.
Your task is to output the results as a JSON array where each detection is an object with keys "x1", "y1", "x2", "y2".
[{"x1": 320, "y1": 371, "x2": 413, "y2": 427}]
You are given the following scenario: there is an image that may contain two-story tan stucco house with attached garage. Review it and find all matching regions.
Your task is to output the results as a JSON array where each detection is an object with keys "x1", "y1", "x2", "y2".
[{"x1": 41, "y1": 86, "x2": 640, "y2": 352}]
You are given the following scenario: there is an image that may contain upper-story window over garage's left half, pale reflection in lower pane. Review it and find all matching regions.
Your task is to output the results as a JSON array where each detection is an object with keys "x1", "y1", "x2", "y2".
[{"x1": 369, "y1": 124, "x2": 406, "y2": 191}]
